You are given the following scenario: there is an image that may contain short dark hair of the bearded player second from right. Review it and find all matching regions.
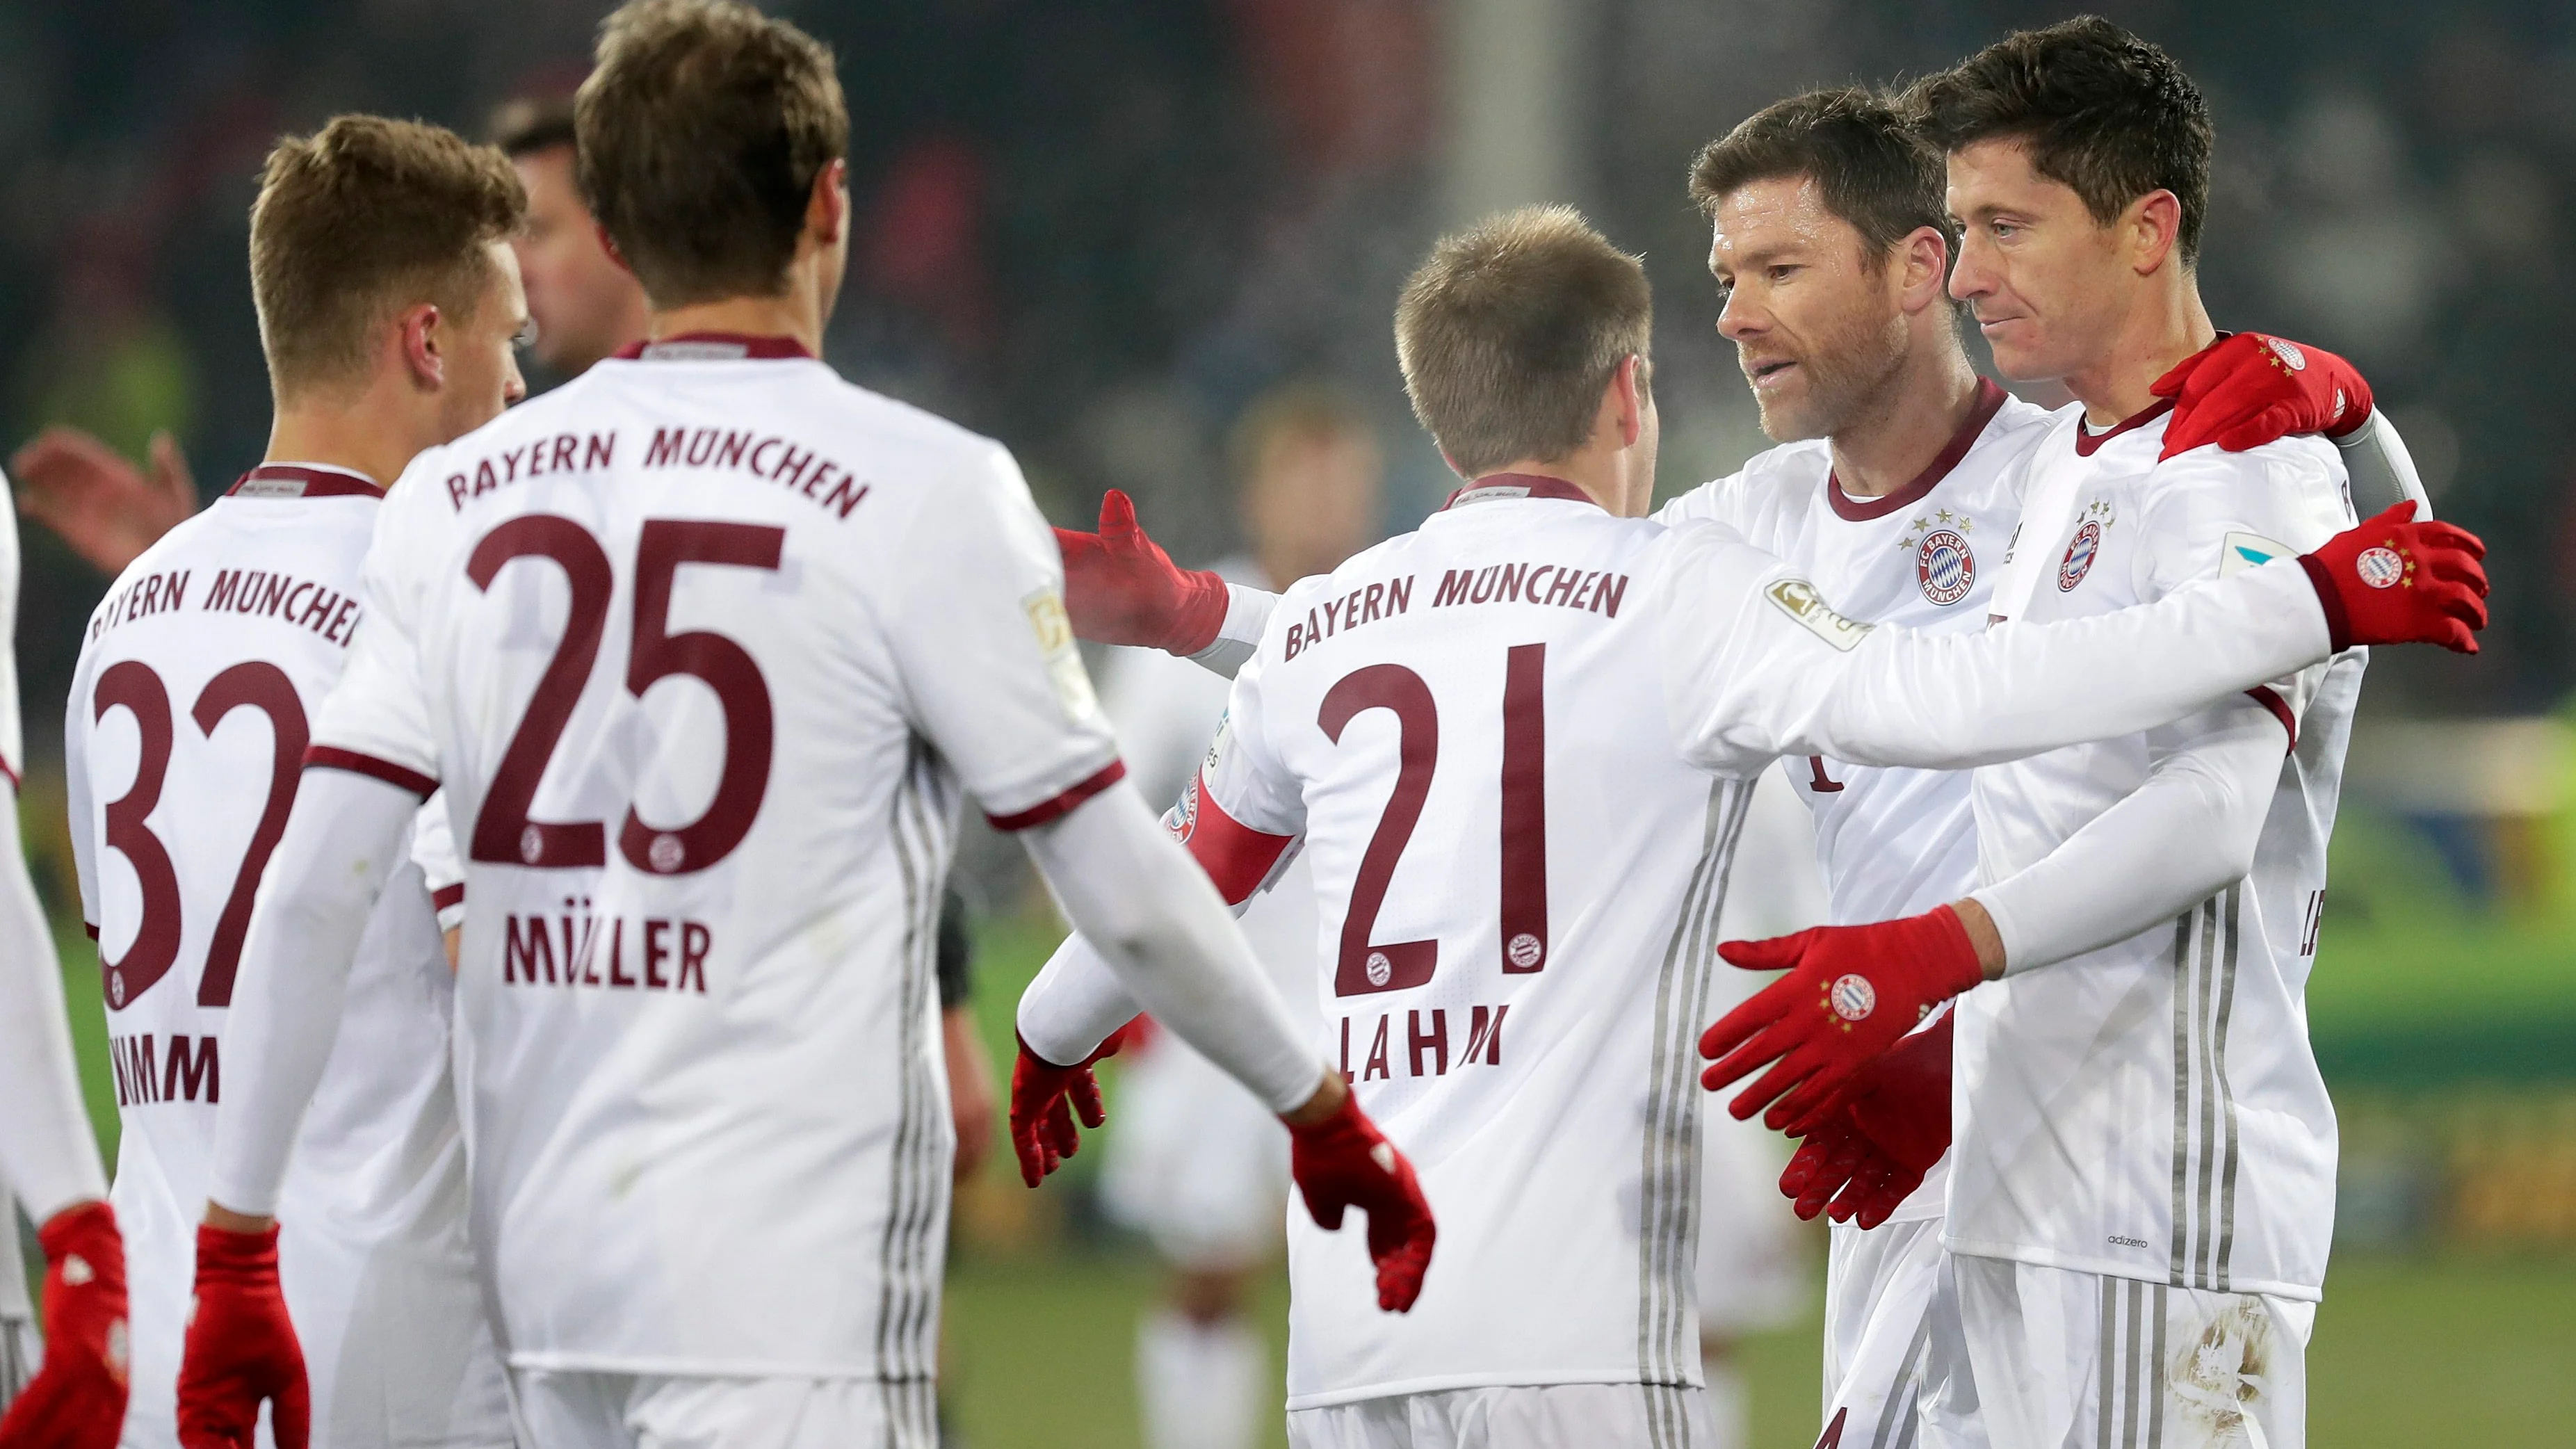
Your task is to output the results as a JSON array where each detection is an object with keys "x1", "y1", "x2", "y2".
[{"x1": 1690, "y1": 85, "x2": 1958, "y2": 266}]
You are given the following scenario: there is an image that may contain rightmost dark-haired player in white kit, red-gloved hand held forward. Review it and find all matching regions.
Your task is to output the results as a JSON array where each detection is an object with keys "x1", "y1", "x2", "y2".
[{"x1": 1706, "y1": 21, "x2": 2462, "y2": 1446}]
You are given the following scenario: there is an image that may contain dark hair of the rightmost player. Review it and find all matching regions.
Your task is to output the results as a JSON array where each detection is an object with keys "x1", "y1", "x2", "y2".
[{"x1": 1906, "y1": 15, "x2": 2213, "y2": 266}]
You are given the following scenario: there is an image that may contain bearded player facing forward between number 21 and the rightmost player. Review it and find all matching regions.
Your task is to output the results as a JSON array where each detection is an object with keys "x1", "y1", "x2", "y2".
[{"x1": 1035, "y1": 90, "x2": 2411, "y2": 1441}]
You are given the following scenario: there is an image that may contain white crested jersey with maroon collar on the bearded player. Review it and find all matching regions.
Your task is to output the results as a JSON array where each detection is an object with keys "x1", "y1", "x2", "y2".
[{"x1": 1656, "y1": 382, "x2": 2050, "y2": 1220}]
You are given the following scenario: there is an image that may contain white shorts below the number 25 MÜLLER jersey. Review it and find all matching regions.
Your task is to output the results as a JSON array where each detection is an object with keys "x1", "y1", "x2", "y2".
[{"x1": 510, "y1": 1369, "x2": 940, "y2": 1449}]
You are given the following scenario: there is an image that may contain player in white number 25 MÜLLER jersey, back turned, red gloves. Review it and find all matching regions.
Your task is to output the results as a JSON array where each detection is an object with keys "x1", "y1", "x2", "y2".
[{"x1": 183, "y1": 0, "x2": 1432, "y2": 1449}]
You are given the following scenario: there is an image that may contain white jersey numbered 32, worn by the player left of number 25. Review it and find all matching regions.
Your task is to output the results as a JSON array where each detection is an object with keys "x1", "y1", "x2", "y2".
[{"x1": 65, "y1": 464, "x2": 510, "y2": 1446}]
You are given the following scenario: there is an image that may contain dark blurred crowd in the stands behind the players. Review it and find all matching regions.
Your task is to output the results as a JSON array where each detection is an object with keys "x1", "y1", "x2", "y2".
[{"x1": 0, "y1": 0, "x2": 2576, "y2": 750}]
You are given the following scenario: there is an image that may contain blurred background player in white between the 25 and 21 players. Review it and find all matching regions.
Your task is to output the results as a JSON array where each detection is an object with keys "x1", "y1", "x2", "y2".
[{"x1": 1100, "y1": 384, "x2": 1386, "y2": 1449}]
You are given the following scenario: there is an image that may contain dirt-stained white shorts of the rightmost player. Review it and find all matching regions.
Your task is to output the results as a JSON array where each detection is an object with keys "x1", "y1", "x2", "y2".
[{"x1": 1916, "y1": 1253, "x2": 2316, "y2": 1449}]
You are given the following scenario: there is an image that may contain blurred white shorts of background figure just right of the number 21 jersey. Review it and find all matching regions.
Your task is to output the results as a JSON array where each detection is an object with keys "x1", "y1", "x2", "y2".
[{"x1": 1698, "y1": 1096, "x2": 1808, "y2": 1338}]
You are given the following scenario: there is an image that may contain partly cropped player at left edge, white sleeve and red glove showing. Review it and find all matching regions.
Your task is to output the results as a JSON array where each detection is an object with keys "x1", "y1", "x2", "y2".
[{"x1": 0, "y1": 485, "x2": 129, "y2": 1449}]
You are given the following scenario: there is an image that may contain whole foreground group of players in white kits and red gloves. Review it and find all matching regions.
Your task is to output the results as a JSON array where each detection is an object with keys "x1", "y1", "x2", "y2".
[{"x1": 0, "y1": 0, "x2": 2486, "y2": 1449}]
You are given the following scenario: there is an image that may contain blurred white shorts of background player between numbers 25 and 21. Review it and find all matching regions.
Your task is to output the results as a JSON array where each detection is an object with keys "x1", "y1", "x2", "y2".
[{"x1": 1100, "y1": 1031, "x2": 1288, "y2": 1271}]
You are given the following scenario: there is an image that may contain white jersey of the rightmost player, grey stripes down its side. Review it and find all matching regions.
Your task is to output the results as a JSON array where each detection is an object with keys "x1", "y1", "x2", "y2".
[{"x1": 1945, "y1": 405, "x2": 2367, "y2": 1300}]
